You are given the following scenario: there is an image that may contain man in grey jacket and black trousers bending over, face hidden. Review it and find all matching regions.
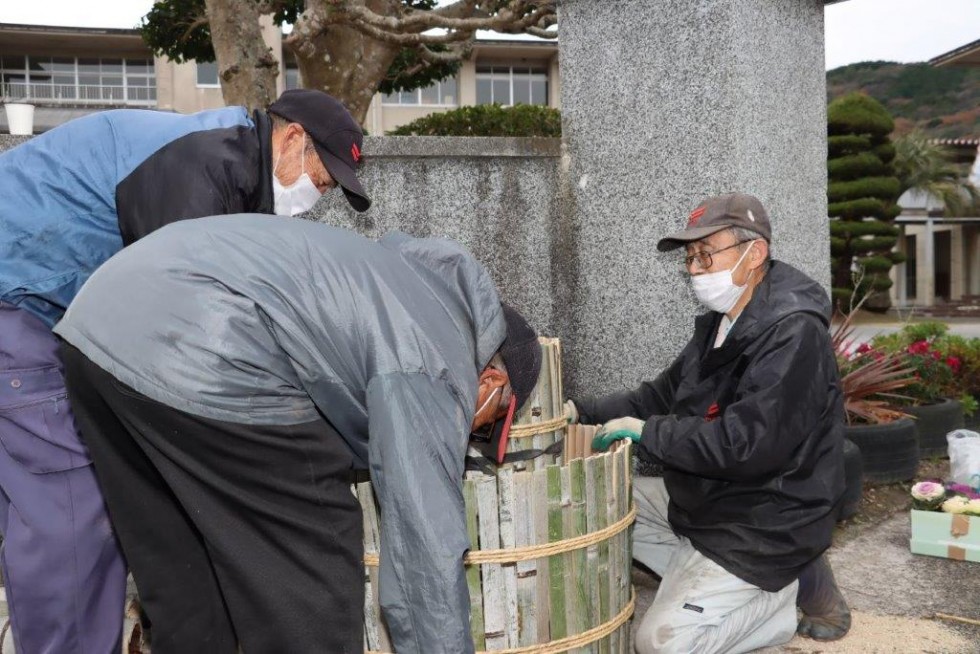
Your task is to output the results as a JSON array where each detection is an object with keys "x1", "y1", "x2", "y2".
[{"x1": 55, "y1": 215, "x2": 541, "y2": 654}]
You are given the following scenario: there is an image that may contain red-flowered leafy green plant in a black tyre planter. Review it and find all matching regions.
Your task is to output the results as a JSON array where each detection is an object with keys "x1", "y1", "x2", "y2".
[{"x1": 873, "y1": 322, "x2": 973, "y2": 457}]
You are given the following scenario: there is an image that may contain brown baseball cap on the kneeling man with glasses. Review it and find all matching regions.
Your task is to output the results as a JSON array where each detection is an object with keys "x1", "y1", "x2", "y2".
[{"x1": 657, "y1": 193, "x2": 772, "y2": 252}]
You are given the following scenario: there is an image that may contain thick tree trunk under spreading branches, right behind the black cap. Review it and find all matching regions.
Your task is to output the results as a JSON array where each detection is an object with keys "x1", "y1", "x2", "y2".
[{"x1": 286, "y1": 25, "x2": 401, "y2": 125}]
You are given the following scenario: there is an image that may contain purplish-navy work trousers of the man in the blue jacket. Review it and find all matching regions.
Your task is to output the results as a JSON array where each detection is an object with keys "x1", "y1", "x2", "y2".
[{"x1": 0, "y1": 302, "x2": 126, "y2": 654}]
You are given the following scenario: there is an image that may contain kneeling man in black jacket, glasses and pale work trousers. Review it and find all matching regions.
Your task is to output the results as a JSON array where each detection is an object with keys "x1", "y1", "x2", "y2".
[{"x1": 576, "y1": 194, "x2": 850, "y2": 654}]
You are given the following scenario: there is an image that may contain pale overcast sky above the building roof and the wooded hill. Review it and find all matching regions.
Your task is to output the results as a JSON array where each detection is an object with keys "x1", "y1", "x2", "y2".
[{"x1": 0, "y1": 0, "x2": 980, "y2": 68}]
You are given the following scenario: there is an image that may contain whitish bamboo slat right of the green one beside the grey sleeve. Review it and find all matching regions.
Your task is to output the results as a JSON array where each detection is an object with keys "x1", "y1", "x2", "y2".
[{"x1": 476, "y1": 476, "x2": 507, "y2": 651}]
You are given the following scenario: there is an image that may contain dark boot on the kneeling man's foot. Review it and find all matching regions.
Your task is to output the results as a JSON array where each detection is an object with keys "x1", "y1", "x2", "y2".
[{"x1": 796, "y1": 555, "x2": 851, "y2": 640}]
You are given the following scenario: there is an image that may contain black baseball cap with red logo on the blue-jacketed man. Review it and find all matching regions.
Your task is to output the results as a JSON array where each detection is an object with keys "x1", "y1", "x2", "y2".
[{"x1": 269, "y1": 89, "x2": 371, "y2": 211}]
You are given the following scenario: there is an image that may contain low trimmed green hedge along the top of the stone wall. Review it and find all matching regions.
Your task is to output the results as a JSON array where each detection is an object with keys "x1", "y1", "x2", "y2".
[{"x1": 388, "y1": 104, "x2": 561, "y2": 137}]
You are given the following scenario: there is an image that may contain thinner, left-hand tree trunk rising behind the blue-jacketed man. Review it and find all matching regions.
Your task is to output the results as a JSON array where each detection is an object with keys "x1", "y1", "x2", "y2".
[{"x1": 205, "y1": 0, "x2": 279, "y2": 110}]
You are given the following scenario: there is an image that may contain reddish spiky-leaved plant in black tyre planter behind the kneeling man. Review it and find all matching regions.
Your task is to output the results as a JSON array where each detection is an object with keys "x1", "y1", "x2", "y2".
[{"x1": 832, "y1": 311, "x2": 919, "y2": 483}]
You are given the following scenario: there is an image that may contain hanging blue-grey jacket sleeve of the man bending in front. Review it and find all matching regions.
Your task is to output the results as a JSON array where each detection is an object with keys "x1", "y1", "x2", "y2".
[{"x1": 367, "y1": 373, "x2": 474, "y2": 654}]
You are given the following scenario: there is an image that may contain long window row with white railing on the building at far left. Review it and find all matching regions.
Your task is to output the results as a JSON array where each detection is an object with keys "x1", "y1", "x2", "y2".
[{"x1": 0, "y1": 55, "x2": 156, "y2": 104}]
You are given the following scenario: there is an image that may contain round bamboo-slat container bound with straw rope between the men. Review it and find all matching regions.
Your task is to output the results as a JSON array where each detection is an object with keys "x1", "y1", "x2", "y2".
[{"x1": 356, "y1": 339, "x2": 635, "y2": 654}]
